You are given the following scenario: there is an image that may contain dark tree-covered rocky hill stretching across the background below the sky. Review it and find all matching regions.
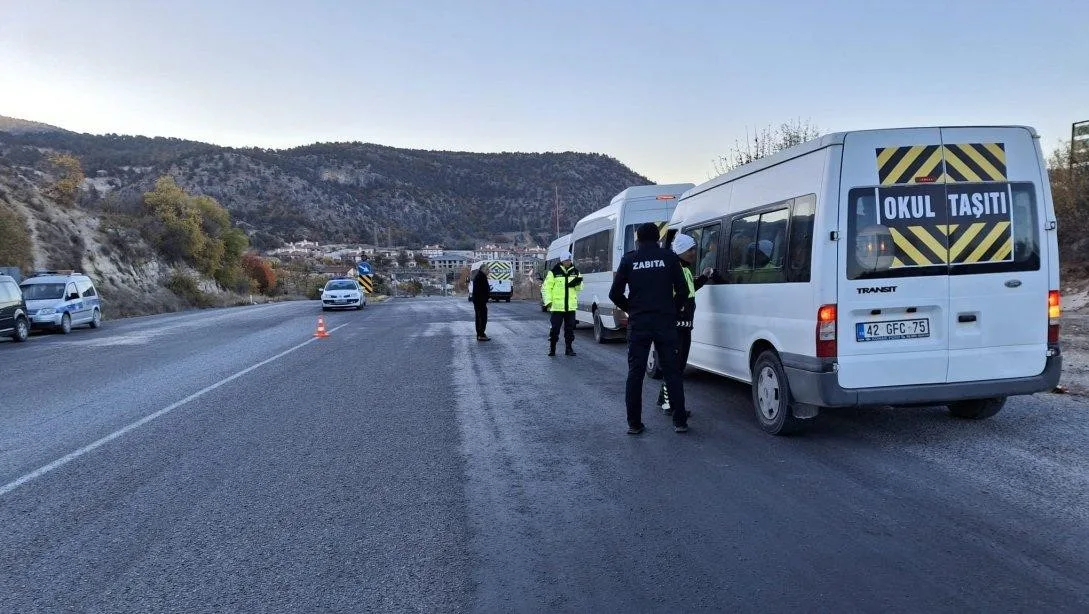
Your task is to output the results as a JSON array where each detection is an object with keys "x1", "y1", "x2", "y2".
[{"x1": 0, "y1": 118, "x2": 651, "y2": 247}]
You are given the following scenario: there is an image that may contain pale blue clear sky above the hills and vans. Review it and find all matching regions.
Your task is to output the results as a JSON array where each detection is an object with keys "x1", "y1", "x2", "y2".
[{"x1": 0, "y1": 0, "x2": 1089, "y2": 183}]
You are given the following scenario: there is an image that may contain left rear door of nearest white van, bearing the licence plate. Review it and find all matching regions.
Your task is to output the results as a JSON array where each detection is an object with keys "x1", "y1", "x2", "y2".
[{"x1": 836, "y1": 128, "x2": 950, "y2": 389}]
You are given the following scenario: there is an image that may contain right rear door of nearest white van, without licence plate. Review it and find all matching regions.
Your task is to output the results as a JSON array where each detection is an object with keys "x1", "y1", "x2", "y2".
[{"x1": 942, "y1": 128, "x2": 1051, "y2": 382}]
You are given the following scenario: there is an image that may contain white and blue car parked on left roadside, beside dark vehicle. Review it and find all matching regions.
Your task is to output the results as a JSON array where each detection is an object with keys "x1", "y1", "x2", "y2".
[{"x1": 20, "y1": 271, "x2": 102, "y2": 334}]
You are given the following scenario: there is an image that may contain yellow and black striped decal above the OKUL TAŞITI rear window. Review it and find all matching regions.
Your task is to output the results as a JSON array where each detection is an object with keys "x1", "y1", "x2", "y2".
[{"x1": 876, "y1": 143, "x2": 1006, "y2": 185}]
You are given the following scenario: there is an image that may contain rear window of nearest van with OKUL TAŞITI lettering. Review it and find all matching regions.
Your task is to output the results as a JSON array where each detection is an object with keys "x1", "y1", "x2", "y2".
[{"x1": 847, "y1": 183, "x2": 1040, "y2": 280}]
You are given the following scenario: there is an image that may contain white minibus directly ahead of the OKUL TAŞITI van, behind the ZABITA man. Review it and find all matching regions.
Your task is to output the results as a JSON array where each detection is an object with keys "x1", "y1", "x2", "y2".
[{"x1": 571, "y1": 183, "x2": 694, "y2": 343}]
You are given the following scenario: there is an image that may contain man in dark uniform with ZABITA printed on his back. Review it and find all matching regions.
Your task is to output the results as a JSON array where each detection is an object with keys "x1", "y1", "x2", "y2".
[{"x1": 609, "y1": 223, "x2": 688, "y2": 434}]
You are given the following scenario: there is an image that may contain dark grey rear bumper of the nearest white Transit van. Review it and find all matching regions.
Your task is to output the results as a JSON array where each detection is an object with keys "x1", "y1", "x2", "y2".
[{"x1": 781, "y1": 347, "x2": 1063, "y2": 407}]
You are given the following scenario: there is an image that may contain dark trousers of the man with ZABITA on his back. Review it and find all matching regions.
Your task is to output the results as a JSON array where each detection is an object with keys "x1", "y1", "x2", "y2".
[{"x1": 624, "y1": 316, "x2": 688, "y2": 427}]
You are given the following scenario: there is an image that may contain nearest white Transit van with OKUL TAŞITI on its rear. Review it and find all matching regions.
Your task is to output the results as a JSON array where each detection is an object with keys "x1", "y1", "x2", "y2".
[{"x1": 668, "y1": 126, "x2": 1062, "y2": 434}]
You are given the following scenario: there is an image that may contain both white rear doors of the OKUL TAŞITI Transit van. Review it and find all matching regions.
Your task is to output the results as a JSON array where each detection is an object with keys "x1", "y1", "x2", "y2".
[{"x1": 837, "y1": 127, "x2": 1049, "y2": 388}]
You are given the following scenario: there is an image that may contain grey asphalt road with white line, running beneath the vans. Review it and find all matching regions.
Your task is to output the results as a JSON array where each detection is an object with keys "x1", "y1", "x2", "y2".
[{"x1": 0, "y1": 299, "x2": 1089, "y2": 613}]
